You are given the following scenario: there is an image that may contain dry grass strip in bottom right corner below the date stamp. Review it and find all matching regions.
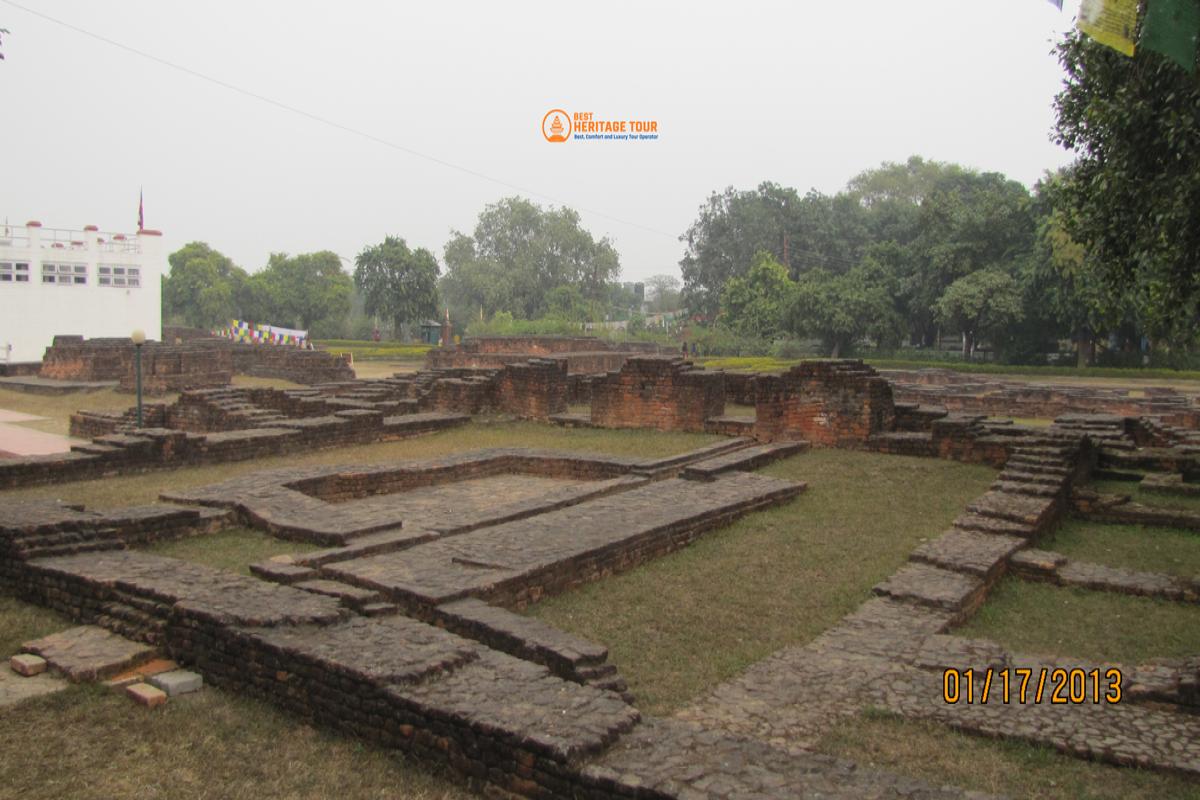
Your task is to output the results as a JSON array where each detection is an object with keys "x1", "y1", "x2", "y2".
[{"x1": 818, "y1": 710, "x2": 1200, "y2": 800}]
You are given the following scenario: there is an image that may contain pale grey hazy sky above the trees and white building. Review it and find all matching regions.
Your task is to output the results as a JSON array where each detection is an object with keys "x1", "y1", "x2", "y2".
[{"x1": 0, "y1": 0, "x2": 1079, "y2": 279}]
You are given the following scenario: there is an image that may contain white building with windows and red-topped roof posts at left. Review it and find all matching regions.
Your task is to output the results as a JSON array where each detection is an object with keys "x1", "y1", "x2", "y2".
[{"x1": 0, "y1": 222, "x2": 167, "y2": 361}]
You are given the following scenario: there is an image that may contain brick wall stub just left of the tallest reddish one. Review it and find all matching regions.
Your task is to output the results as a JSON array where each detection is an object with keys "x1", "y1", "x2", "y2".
[{"x1": 592, "y1": 356, "x2": 725, "y2": 431}]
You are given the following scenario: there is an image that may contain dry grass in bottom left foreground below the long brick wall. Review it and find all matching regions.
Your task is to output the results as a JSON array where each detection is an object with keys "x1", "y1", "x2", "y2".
[{"x1": 0, "y1": 685, "x2": 474, "y2": 800}]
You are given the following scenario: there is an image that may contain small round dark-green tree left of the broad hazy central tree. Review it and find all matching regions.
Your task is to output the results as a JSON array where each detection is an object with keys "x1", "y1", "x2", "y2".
[{"x1": 354, "y1": 236, "x2": 438, "y2": 336}]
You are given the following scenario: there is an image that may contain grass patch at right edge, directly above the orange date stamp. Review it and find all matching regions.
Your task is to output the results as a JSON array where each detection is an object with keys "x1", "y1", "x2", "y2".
[{"x1": 1040, "y1": 519, "x2": 1200, "y2": 578}]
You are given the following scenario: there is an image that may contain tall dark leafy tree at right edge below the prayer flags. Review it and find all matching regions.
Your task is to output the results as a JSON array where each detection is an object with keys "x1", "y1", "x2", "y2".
[{"x1": 1054, "y1": 32, "x2": 1200, "y2": 342}]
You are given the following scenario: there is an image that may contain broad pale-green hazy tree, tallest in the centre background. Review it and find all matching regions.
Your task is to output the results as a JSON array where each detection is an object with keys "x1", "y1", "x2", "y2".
[{"x1": 439, "y1": 197, "x2": 620, "y2": 319}]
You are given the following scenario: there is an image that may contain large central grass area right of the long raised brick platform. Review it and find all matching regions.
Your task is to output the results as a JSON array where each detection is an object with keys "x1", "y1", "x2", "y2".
[{"x1": 528, "y1": 450, "x2": 995, "y2": 714}]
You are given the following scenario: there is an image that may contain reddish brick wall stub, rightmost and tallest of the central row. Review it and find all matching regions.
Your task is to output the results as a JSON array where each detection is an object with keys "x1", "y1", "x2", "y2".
[{"x1": 755, "y1": 361, "x2": 895, "y2": 447}]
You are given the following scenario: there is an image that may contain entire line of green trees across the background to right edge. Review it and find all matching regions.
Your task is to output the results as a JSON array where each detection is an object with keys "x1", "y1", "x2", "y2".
[{"x1": 163, "y1": 32, "x2": 1200, "y2": 363}]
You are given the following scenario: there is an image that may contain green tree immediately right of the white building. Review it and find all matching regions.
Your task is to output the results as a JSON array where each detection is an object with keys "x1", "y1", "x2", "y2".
[{"x1": 162, "y1": 241, "x2": 246, "y2": 327}]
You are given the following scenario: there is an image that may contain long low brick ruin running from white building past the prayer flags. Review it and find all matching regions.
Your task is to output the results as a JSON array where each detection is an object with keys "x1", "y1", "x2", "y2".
[{"x1": 38, "y1": 336, "x2": 355, "y2": 395}]
